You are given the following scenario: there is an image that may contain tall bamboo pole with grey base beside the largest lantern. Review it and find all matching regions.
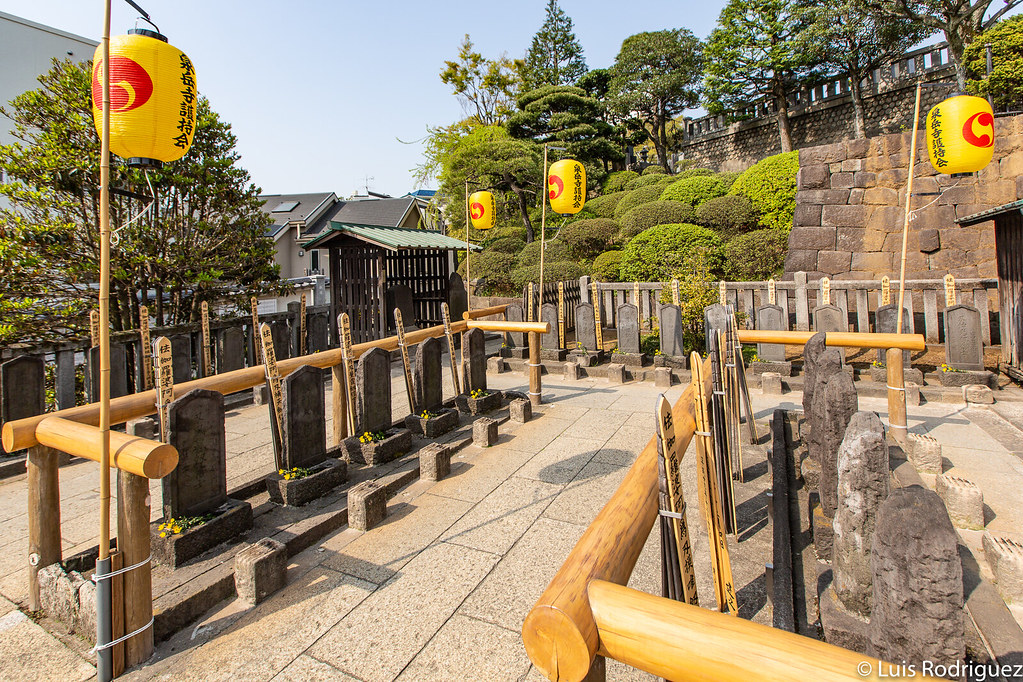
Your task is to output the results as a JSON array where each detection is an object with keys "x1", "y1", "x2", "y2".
[{"x1": 95, "y1": 0, "x2": 114, "y2": 682}]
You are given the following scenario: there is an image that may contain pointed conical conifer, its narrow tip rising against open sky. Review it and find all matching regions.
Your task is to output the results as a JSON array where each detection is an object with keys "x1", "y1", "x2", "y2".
[{"x1": 523, "y1": 0, "x2": 586, "y2": 90}]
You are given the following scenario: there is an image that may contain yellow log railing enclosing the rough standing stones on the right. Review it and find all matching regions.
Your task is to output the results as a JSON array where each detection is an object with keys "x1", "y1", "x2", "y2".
[{"x1": 522, "y1": 331, "x2": 923, "y2": 682}]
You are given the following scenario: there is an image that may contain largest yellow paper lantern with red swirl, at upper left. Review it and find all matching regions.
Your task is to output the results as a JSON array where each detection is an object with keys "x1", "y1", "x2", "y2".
[{"x1": 92, "y1": 29, "x2": 198, "y2": 167}]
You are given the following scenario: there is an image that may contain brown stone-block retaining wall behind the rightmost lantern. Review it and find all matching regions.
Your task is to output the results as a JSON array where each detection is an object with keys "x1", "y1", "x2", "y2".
[{"x1": 785, "y1": 116, "x2": 1023, "y2": 279}]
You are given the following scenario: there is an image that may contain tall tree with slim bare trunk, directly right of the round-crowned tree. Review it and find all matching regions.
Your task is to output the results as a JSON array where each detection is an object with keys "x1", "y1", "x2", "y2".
[{"x1": 704, "y1": 0, "x2": 820, "y2": 151}]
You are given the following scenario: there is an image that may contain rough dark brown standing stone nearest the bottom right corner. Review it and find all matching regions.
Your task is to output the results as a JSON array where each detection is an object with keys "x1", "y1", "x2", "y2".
[{"x1": 871, "y1": 486, "x2": 966, "y2": 671}]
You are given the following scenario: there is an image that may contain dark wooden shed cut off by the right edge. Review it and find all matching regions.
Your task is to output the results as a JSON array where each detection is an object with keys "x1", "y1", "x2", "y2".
[{"x1": 957, "y1": 199, "x2": 1023, "y2": 381}]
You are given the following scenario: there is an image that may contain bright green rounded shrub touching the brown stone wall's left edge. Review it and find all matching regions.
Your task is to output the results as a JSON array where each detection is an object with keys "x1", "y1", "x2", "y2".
[{"x1": 728, "y1": 151, "x2": 799, "y2": 232}]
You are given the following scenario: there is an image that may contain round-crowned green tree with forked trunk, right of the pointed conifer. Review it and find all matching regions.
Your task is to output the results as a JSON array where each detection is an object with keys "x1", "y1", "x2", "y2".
[{"x1": 609, "y1": 29, "x2": 704, "y2": 173}]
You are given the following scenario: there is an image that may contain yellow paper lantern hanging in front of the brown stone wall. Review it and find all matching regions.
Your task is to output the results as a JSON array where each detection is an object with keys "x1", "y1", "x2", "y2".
[{"x1": 927, "y1": 95, "x2": 994, "y2": 175}]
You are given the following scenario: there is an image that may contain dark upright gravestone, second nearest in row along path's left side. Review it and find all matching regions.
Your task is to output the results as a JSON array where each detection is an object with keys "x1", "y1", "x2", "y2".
[{"x1": 281, "y1": 365, "x2": 326, "y2": 469}]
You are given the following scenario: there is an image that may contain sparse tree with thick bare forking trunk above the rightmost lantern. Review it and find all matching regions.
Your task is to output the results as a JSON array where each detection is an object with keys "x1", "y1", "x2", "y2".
[{"x1": 860, "y1": 0, "x2": 1023, "y2": 91}]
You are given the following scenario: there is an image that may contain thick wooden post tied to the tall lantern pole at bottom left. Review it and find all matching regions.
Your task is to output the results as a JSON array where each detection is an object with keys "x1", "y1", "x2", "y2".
[{"x1": 118, "y1": 471, "x2": 153, "y2": 668}]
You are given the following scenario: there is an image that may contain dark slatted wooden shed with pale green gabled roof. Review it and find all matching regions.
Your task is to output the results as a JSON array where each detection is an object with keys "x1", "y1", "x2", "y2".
[{"x1": 304, "y1": 221, "x2": 479, "y2": 344}]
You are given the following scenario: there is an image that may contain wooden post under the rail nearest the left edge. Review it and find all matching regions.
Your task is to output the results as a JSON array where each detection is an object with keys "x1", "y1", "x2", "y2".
[{"x1": 26, "y1": 445, "x2": 61, "y2": 611}]
